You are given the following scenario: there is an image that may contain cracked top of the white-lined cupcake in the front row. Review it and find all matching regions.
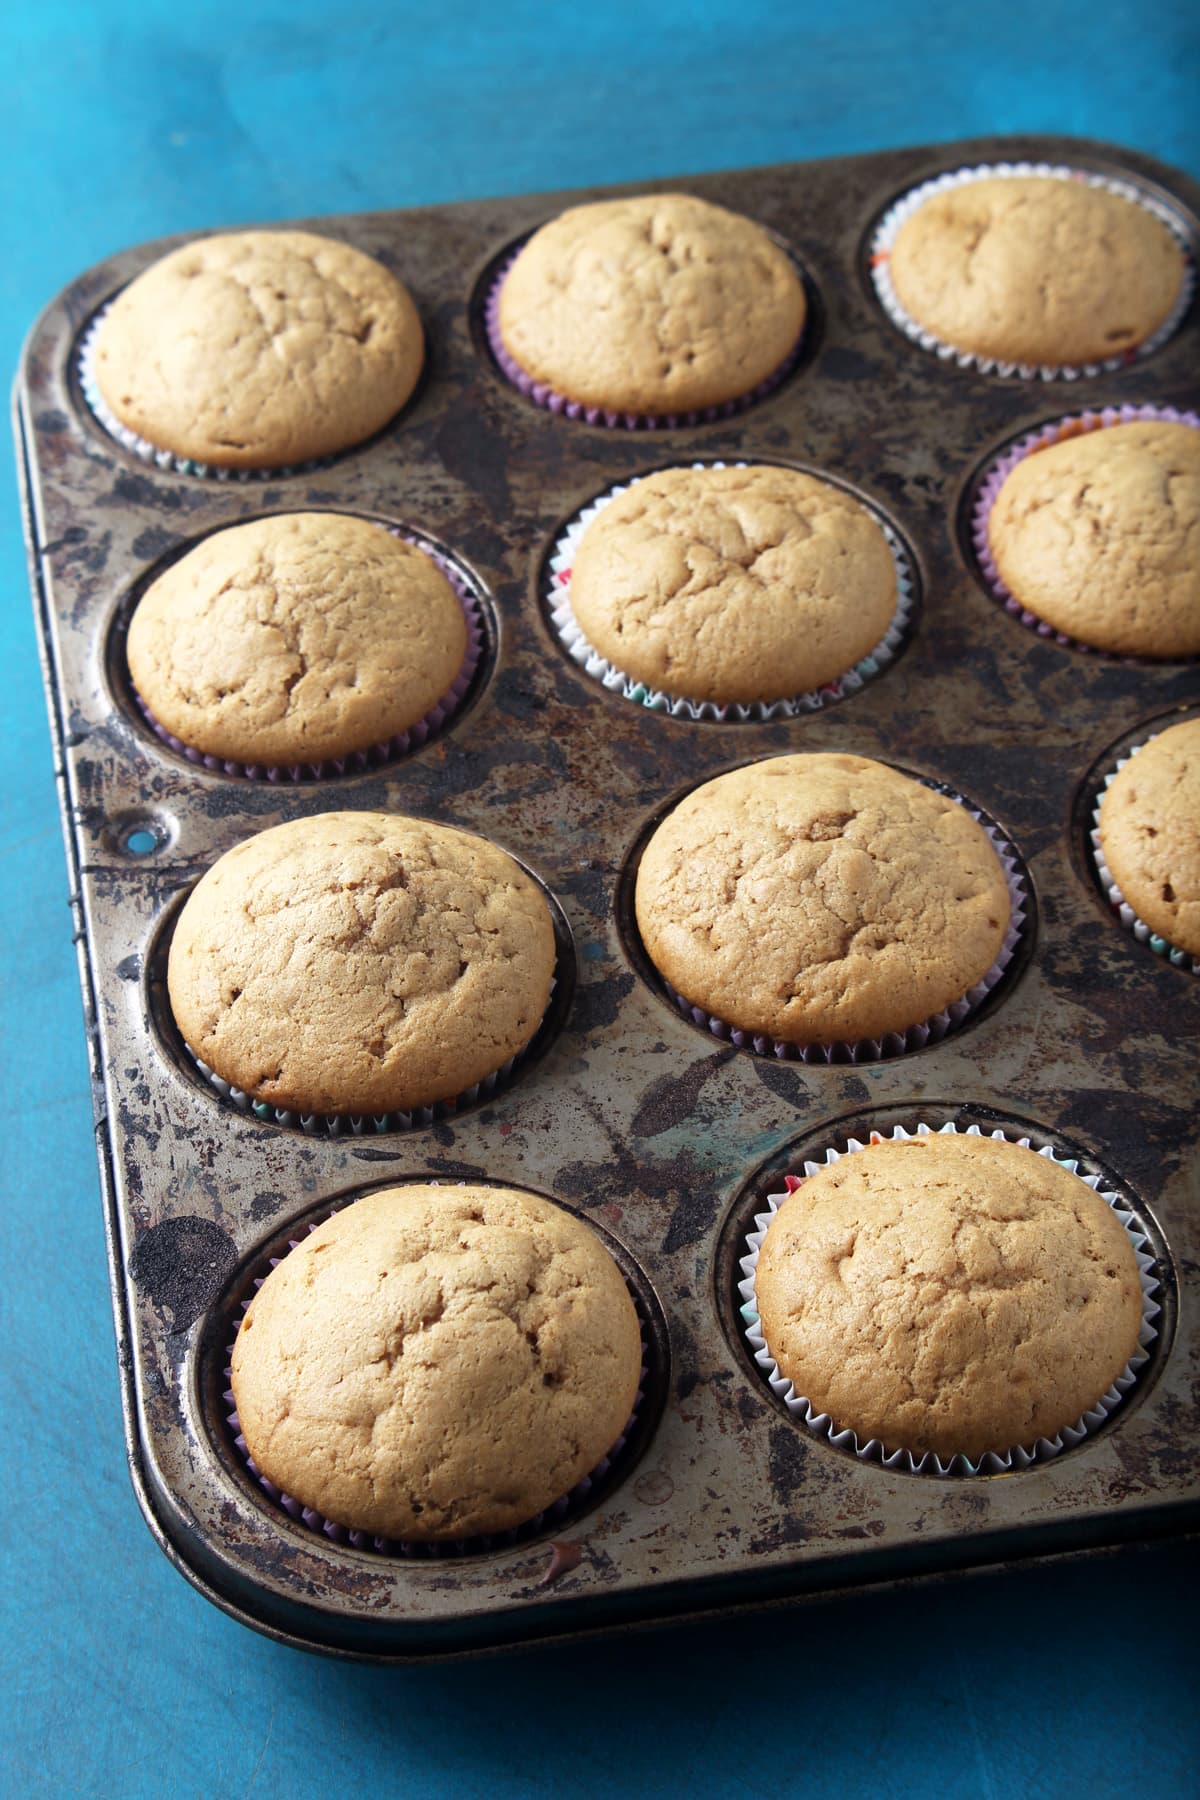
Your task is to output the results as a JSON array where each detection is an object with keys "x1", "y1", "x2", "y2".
[{"x1": 756, "y1": 1134, "x2": 1142, "y2": 1458}]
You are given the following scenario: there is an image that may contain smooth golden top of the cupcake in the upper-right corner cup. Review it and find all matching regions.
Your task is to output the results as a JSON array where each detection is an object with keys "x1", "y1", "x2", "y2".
[{"x1": 891, "y1": 175, "x2": 1184, "y2": 367}]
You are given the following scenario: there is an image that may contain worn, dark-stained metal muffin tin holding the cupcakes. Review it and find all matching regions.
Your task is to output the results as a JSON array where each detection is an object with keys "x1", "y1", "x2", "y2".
[{"x1": 16, "y1": 139, "x2": 1200, "y2": 1660}]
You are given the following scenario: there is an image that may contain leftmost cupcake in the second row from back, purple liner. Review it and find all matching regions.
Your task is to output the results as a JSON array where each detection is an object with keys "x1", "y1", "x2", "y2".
[{"x1": 126, "y1": 513, "x2": 479, "y2": 774}]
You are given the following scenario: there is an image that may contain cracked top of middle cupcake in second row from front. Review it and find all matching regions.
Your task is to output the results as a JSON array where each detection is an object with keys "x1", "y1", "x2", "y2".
[{"x1": 635, "y1": 754, "x2": 1009, "y2": 1044}]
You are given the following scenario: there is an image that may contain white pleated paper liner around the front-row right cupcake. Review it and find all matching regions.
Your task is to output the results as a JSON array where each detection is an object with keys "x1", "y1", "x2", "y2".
[{"x1": 738, "y1": 1121, "x2": 1162, "y2": 1478}]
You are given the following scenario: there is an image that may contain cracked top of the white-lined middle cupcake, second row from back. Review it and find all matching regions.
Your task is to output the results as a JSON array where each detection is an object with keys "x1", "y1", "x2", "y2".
[{"x1": 570, "y1": 466, "x2": 896, "y2": 702}]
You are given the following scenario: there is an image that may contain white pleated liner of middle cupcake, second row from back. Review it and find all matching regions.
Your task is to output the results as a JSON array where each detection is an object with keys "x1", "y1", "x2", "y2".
[{"x1": 543, "y1": 463, "x2": 916, "y2": 724}]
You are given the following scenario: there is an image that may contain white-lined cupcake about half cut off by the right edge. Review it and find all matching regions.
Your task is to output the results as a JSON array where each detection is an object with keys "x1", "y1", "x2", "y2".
[{"x1": 1096, "y1": 718, "x2": 1200, "y2": 967}]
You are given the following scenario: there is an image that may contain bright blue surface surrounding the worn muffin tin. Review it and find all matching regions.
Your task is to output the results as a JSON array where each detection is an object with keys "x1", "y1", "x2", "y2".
[{"x1": 0, "y1": 0, "x2": 1200, "y2": 1800}]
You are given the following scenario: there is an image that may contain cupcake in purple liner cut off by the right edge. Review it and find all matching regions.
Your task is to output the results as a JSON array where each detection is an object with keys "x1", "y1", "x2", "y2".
[{"x1": 986, "y1": 418, "x2": 1200, "y2": 657}]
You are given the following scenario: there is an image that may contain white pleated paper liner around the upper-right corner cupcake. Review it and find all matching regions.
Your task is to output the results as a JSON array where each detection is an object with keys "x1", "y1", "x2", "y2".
[{"x1": 869, "y1": 162, "x2": 1196, "y2": 382}]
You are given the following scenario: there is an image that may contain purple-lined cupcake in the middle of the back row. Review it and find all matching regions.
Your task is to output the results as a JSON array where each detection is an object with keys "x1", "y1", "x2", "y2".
[{"x1": 489, "y1": 194, "x2": 806, "y2": 423}]
